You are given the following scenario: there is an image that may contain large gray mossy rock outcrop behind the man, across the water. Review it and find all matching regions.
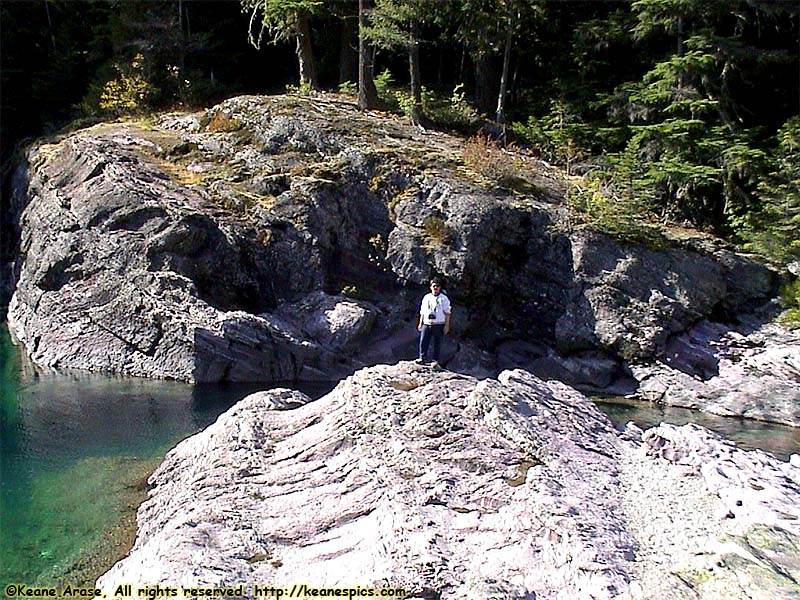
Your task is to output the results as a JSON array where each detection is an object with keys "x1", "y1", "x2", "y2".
[{"x1": 9, "y1": 97, "x2": 792, "y2": 408}]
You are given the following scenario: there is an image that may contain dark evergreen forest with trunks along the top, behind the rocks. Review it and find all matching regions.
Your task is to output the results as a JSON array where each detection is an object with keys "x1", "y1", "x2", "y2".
[{"x1": 0, "y1": 0, "x2": 800, "y2": 276}]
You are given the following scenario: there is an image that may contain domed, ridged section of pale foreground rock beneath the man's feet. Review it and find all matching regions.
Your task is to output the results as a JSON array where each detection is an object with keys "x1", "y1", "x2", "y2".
[{"x1": 101, "y1": 363, "x2": 632, "y2": 599}]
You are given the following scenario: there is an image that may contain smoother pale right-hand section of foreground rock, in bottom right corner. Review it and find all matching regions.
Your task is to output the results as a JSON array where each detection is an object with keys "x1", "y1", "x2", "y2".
[{"x1": 621, "y1": 425, "x2": 800, "y2": 600}]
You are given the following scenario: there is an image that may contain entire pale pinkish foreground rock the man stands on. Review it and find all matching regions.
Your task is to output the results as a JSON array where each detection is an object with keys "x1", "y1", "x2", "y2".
[{"x1": 98, "y1": 363, "x2": 800, "y2": 600}]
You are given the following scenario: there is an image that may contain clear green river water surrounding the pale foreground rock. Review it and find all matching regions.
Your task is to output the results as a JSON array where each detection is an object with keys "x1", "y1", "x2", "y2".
[{"x1": 0, "y1": 325, "x2": 800, "y2": 590}]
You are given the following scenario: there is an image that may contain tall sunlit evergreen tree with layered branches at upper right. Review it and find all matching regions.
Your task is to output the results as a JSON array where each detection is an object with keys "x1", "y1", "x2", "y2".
[{"x1": 609, "y1": 0, "x2": 788, "y2": 231}]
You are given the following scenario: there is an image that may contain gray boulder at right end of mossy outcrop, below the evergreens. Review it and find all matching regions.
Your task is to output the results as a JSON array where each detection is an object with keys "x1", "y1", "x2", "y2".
[{"x1": 555, "y1": 233, "x2": 775, "y2": 360}]
